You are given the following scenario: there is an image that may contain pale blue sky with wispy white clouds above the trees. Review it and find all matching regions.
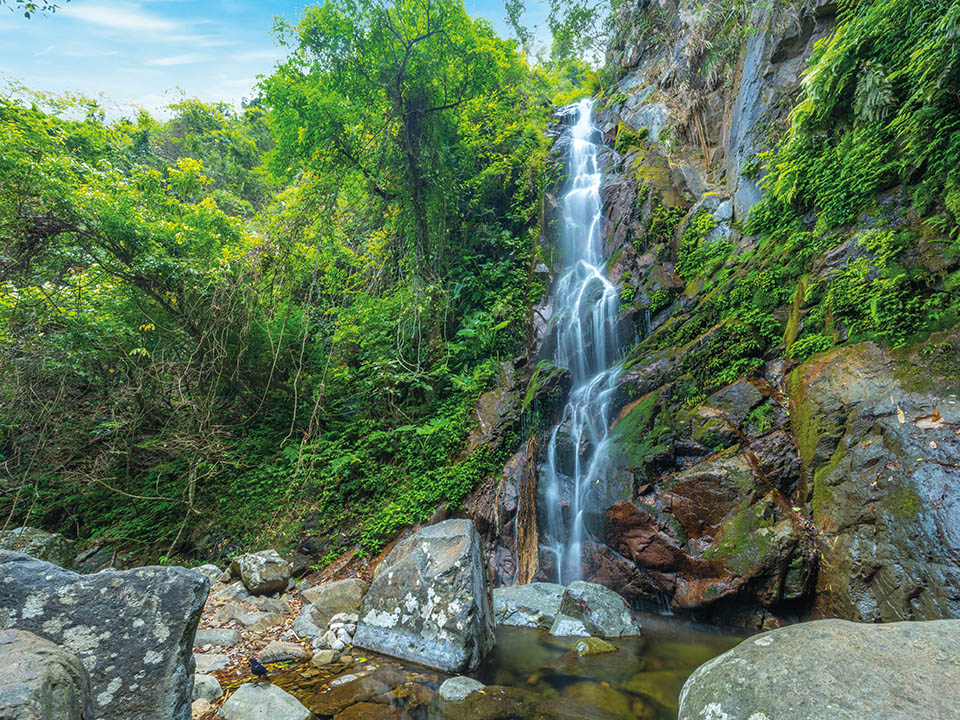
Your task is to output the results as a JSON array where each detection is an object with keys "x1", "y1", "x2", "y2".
[{"x1": 0, "y1": 0, "x2": 543, "y2": 114}]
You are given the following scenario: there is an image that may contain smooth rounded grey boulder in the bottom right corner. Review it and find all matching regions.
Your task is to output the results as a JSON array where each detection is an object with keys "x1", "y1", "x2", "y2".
[{"x1": 679, "y1": 620, "x2": 960, "y2": 720}]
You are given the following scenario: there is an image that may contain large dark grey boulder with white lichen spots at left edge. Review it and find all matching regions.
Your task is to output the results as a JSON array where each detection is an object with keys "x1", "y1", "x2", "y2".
[{"x1": 0, "y1": 551, "x2": 210, "y2": 720}]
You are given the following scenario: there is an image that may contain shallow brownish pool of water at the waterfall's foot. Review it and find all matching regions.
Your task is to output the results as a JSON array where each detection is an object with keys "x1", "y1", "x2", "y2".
[{"x1": 210, "y1": 616, "x2": 742, "y2": 720}]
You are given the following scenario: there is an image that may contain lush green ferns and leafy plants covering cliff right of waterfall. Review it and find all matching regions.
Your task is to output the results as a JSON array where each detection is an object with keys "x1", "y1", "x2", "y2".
[{"x1": 632, "y1": 0, "x2": 960, "y2": 396}]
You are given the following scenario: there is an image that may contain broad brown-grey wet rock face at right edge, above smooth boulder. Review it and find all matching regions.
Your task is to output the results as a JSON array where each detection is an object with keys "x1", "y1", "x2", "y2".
[{"x1": 788, "y1": 328, "x2": 960, "y2": 622}]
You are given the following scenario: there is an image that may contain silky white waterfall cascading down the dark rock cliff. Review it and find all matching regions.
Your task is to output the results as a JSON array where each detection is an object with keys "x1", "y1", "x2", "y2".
[{"x1": 540, "y1": 100, "x2": 620, "y2": 583}]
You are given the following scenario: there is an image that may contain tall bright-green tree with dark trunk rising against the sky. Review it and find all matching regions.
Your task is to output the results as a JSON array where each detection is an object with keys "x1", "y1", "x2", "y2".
[{"x1": 262, "y1": 0, "x2": 524, "y2": 277}]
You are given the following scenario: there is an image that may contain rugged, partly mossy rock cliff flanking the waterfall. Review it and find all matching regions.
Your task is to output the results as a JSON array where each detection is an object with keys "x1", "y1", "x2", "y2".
[{"x1": 467, "y1": 0, "x2": 960, "y2": 627}]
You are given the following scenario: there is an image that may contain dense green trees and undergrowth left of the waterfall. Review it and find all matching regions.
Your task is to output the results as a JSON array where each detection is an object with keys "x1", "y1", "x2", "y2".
[{"x1": 0, "y1": 0, "x2": 582, "y2": 555}]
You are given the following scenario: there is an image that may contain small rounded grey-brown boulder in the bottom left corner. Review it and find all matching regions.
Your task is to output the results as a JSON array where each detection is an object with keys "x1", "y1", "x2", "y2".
[{"x1": 0, "y1": 630, "x2": 93, "y2": 720}]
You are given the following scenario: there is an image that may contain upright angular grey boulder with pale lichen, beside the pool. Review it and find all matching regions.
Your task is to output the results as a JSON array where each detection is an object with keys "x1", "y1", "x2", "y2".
[{"x1": 354, "y1": 520, "x2": 494, "y2": 673}]
